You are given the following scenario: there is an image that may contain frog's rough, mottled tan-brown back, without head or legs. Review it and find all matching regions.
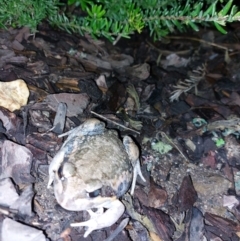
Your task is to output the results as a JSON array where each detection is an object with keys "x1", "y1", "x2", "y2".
[{"x1": 66, "y1": 130, "x2": 132, "y2": 196}]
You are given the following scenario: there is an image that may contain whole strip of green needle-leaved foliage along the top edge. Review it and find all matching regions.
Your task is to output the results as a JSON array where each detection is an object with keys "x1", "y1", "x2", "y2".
[{"x1": 0, "y1": 0, "x2": 240, "y2": 41}]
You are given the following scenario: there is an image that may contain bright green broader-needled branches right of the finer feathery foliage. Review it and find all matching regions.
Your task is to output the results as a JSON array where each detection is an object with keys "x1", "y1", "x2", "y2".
[{"x1": 59, "y1": 0, "x2": 240, "y2": 40}]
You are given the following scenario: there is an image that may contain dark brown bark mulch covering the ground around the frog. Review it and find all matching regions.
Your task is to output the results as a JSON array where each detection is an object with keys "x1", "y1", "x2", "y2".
[{"x1": 0, "y1": 21, "x2": 240, "y2": 241}]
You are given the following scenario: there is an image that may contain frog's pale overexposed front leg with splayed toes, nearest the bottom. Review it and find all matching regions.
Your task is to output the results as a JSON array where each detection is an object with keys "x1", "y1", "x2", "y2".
[{"x1": 71, "y1": 199, "x2": 125, "y2": 238}]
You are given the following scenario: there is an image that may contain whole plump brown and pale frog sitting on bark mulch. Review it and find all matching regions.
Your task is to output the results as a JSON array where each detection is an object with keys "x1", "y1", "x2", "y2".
[{"x1": 48, "y1": 118, "x2": 146, "y2": 238}]
